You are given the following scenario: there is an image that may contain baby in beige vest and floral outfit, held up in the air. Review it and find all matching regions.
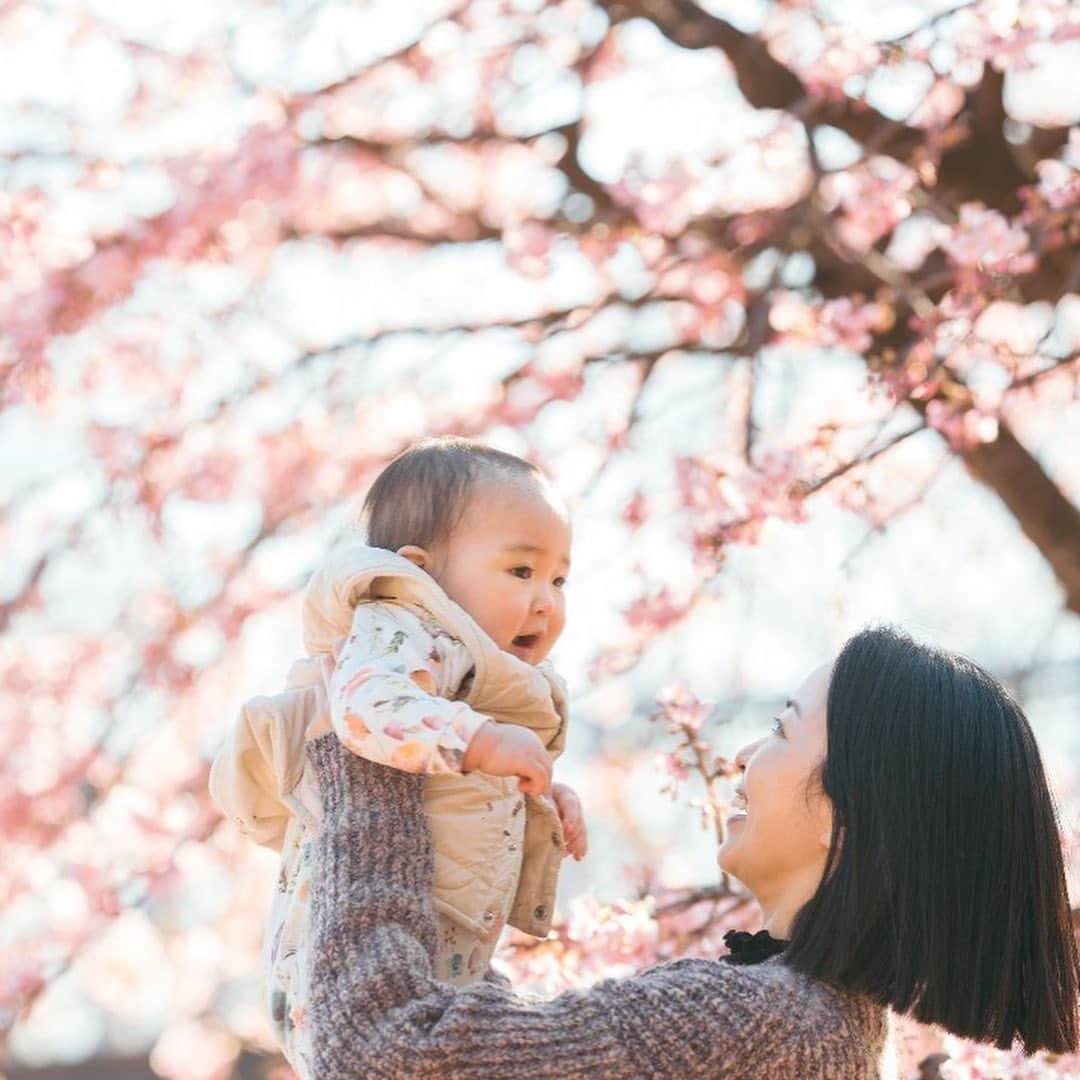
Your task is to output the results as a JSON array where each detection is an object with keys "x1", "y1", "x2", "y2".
[{"x1": 211, "y1": 438, "x2": 588, "y2": 1080}]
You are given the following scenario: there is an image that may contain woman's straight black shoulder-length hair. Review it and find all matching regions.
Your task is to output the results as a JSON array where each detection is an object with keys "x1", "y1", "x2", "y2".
[{"x1": 785, "y1": 627, "x2": 1080, "y2": 1053}]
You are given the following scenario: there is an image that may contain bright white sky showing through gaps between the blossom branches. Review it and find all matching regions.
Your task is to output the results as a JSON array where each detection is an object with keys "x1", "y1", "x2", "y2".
[{"x1": 0, "y1": 0, "x2": 1080, "y2": 1059}]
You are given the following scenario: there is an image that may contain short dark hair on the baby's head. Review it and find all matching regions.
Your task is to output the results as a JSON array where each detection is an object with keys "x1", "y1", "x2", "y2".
[{"x1": 360, "y1": 436, "x2": 543, "y2": 551}]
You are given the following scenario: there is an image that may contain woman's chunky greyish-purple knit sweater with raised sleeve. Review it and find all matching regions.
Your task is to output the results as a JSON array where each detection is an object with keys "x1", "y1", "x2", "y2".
[{"x1": 308, "y1": 733, "x2": 887, "y2": 1080}]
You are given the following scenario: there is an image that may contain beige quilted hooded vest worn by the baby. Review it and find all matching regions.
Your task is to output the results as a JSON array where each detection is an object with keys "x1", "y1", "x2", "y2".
[{"x1": 211, "y1": 543, "x2": 566, "y2": 936}]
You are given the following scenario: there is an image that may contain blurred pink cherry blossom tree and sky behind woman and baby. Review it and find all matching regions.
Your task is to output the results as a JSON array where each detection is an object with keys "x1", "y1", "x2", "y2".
[{"x1": 0, "y1": 0, "x2": 1080, "y2": 1080}]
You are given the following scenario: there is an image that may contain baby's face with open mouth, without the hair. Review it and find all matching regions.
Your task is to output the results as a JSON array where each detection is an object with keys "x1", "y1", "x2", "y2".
[{"x1": 430, "y1": 482, "x2": 570, "y2": 664}]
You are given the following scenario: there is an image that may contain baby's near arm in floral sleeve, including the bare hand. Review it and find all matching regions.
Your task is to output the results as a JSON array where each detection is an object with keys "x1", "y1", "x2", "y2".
[{"x1": 329, "y1": 602, "x2": 551, "y2": 793}]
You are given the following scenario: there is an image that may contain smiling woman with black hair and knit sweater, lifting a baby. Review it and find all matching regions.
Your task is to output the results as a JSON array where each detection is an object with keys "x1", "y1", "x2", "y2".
[{"x1": 309, "y1": 629, "x2": 1080, "y2": 1080}]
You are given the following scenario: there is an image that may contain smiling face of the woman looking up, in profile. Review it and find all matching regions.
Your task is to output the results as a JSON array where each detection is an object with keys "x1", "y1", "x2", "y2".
[{"x1": 717, "y1": 664, "x2": 833, "y2": 915}]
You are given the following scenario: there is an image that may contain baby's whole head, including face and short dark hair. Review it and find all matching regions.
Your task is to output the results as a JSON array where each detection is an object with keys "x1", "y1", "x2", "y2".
[{"x1": 363, "y1": 438, "x2": 570, "y2": 664}]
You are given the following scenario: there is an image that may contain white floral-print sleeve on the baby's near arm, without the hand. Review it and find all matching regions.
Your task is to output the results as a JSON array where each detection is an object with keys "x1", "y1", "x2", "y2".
[{"x1": 329, "y1": 602, "x2": 487, "y2": 773}]
